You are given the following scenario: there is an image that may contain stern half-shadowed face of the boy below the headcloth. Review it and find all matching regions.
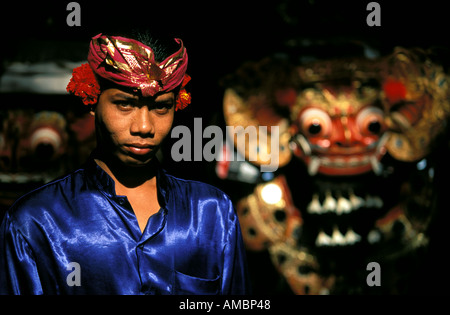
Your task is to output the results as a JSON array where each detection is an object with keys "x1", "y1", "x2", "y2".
[{"x1": 95, "y1": 88, "x2": 175, "y2": 166}]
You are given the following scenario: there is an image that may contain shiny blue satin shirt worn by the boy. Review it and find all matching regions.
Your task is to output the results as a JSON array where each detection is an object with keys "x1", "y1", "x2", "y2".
[{"x1": 0, "y1": 159, "x2": 248, "y2": 294}]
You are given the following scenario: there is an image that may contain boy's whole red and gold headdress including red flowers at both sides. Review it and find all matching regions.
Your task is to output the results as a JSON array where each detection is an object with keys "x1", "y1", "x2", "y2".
[{"x1": 67, "y1": 34, "x2": 191, "y2": 110}]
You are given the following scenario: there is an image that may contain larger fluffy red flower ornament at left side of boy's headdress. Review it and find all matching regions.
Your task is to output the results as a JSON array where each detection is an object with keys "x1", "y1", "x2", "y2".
[{"x1": 66, "y1": 63, "x2": 100, "y2": 105}]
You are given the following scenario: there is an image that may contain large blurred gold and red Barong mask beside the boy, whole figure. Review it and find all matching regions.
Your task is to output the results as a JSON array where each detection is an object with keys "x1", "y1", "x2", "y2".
[{"x1": 221, "y1": 48, "x2": 450, "y2": 294}]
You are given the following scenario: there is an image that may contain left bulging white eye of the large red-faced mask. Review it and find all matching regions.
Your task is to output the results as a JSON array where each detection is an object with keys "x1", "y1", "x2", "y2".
[{"x1": 299, "y1": 108, "x2": 331, "y2": 137}]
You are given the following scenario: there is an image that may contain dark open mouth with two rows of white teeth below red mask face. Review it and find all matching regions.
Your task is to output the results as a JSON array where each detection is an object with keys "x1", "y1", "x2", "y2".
[{"x1": 291, "y1": 167, "x2": 399, "y2": 259}]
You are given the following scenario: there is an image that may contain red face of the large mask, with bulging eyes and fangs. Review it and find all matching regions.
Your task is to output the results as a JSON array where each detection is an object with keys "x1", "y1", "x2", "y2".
[{"x1": 294, "y1": 85, "x2": 386, "y2": 176}]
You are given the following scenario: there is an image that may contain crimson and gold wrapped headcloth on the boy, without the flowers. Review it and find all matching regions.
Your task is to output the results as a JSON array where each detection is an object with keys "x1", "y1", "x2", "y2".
[{"x1": 88, "y1": 34, "x2": 188, "y2": 97}]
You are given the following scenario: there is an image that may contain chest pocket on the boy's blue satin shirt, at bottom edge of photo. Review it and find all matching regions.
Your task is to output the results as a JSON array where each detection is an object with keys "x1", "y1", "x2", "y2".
[{"x1": 173, "y1": 270, "x2": 221, "y2": 295}]
